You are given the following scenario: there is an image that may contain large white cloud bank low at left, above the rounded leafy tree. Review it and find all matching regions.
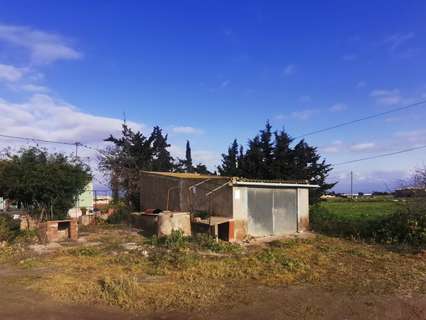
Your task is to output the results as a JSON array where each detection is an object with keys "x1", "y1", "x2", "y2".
[{"x1": 0, "y1": 94, "x2": 142, "y2": 143}]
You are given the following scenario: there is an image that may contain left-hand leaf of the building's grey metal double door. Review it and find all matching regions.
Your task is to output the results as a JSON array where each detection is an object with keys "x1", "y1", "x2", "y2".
[{"x1": 247, "y1": 188, "x2": 274, "y2": 236}]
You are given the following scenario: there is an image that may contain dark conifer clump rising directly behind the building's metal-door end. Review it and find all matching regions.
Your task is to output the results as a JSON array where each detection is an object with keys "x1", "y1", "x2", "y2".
[{"x1": 218, "y1": 122, "x2": 335, "y2": 202}]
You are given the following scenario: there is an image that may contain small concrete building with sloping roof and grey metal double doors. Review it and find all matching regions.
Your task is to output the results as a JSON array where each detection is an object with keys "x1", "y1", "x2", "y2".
[{"x1": 140, "y1": 171, "x2": 318, "y2": 240}]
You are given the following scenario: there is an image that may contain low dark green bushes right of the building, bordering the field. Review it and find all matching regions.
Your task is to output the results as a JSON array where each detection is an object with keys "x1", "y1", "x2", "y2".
[{"x1": 310, "y1": 201, "x2": 426, "y2": 247}]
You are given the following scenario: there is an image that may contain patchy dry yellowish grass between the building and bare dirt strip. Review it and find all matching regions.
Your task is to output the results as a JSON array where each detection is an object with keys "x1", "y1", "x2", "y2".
[{"x1": 3, "y1": 228, "x2": 426, "y2": 311}]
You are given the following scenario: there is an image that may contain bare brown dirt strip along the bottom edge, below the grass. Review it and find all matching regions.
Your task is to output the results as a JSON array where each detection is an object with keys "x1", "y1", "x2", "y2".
[{"x1": 0, "y1": 269, "x2": 426, "y2": 320}]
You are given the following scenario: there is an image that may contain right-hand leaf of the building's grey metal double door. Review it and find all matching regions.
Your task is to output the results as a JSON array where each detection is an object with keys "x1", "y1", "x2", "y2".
[{"x1": 272, "y1": 189, "x2": 297, "y2": 235}]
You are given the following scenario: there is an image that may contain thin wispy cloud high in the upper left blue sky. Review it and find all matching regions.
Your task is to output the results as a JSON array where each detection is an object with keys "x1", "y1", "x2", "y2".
[{"x1": 0, "y1": 24, "x2": 82, "y2": 64}]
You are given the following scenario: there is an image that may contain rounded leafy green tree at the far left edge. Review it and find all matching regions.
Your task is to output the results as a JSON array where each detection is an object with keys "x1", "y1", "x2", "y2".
[{"x1": 0, "y1": 148, "x2": 91, "y2": 219}]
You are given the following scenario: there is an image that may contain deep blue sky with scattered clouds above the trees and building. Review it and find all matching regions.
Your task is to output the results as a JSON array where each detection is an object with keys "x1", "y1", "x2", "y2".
[{"x1": 0, "y1": 0, "x2": 426, "y2": 192}]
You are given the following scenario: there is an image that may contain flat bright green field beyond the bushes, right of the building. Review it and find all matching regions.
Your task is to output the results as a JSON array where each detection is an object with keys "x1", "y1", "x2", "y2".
[{"x1": 320, "y1": 199, "x2": 402, "y2": 220}]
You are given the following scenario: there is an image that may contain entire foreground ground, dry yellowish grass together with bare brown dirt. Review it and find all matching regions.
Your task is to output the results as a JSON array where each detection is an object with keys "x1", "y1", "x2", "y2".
[{"x1": 0, "y1": 228, "x2": 426, "y2": 320}]
